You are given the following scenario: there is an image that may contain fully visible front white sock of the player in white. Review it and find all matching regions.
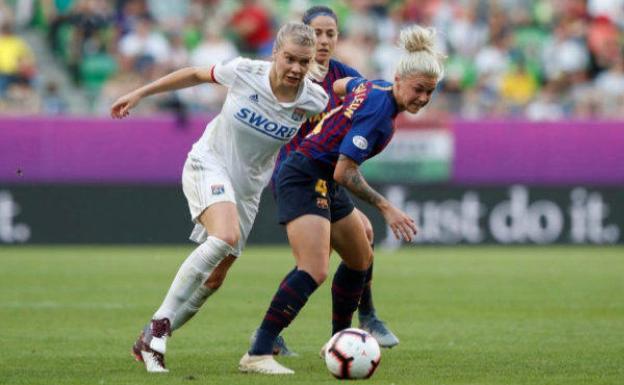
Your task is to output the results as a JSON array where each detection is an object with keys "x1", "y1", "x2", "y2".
[{"x1": 153, "y1": 237, "x2": 233, "y2": 321}]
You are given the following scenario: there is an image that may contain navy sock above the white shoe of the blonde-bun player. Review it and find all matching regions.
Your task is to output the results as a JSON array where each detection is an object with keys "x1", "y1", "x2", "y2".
[{"x1": 249, "y1": 270, "x2": 318, "y2": 355}]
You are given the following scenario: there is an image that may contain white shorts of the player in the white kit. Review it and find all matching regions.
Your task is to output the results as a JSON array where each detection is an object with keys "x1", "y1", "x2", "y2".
[{"x1": 182, "y1": 157, "x2": 262, "y2": 257}]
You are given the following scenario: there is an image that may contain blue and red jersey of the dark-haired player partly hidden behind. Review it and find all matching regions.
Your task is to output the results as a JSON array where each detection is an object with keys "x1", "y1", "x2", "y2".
[{"x1": 271, "y1": 59, "x2": 362, "y2": 183}]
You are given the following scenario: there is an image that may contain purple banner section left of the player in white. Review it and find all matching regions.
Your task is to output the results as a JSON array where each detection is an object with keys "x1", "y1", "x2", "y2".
[{"x1": 0, "y1": 118, "x2": 207, "y2": 183}]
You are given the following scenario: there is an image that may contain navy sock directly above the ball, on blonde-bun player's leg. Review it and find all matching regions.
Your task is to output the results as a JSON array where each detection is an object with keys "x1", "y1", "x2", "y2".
[{"x1": 332, "y1": 263, "x2": 367, "y2": 335}]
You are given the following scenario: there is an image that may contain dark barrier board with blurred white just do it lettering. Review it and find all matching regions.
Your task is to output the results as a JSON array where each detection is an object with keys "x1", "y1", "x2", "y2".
[{"x1": 0, "y1": 185, "x2": 624, "y2": 247}]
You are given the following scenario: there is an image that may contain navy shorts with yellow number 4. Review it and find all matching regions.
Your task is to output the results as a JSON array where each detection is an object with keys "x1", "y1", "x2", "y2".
[{"x1": 275, "y1": 152, "x2": 355, "y2": 225}]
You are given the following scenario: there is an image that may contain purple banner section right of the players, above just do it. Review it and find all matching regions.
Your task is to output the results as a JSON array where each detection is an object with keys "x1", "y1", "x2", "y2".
[{"x1": 452, "y1": 121, "x2": 624, "y2": 185}]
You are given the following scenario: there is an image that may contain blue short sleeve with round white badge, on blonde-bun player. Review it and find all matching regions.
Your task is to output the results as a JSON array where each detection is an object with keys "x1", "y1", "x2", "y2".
[{"x1": 339, "y1": 100, "x2": 388, "y2": 164}]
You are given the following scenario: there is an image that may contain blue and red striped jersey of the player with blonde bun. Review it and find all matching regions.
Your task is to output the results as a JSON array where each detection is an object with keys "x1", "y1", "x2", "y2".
[{"x1": 297, "y1": 78, "x2": 399, "y2": 167}]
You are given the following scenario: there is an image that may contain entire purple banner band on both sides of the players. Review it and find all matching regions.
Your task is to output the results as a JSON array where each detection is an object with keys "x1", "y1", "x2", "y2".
[{"x1": 0, "y1": 117, "x2": 624, "y2": 185}]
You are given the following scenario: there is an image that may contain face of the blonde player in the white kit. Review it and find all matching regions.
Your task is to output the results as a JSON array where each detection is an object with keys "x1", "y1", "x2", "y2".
[{"x1": 273, "y1": 41, "x2": 314, "y2": 87}]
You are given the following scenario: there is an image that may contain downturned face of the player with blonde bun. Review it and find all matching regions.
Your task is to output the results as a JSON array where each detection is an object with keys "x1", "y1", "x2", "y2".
[{"x1": 394, "y1": 74, "x2": 438, "y2": 114}]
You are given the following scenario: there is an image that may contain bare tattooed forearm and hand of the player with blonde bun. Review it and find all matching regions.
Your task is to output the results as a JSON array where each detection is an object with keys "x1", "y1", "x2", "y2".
[{"x1": 334, "y1": 154, "x2": 418, "y2": 242}]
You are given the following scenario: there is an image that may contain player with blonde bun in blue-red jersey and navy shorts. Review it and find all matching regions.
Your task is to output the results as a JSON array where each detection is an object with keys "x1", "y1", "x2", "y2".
[{"x1": 239, "y1": 26, "x2": 443, "y2": 374}]
